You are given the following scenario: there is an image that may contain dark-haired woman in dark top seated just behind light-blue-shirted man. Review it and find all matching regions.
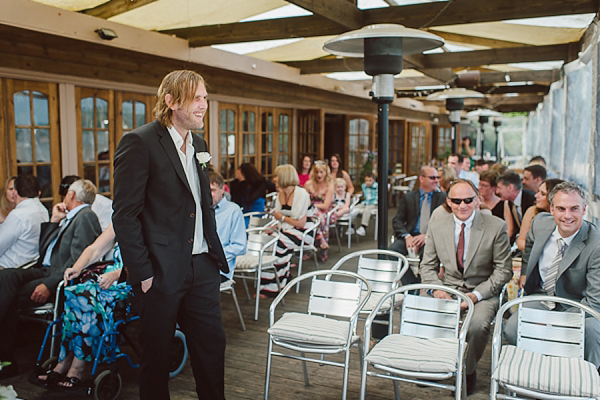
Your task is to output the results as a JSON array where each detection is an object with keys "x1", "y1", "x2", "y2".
[{"x1": 231, "y1": 163, "x2": 270, "y2": 223}]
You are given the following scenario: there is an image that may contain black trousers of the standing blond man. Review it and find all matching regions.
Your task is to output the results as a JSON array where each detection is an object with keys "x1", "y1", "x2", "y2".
[{"x1": 134, "y1": 254, "x2": 225, "y2": 400}]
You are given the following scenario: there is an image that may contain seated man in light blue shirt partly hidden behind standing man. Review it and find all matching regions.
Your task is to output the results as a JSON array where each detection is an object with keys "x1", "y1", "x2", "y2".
[{"x1": 208, "y1": 171, "x2": 246, "y2": 282}]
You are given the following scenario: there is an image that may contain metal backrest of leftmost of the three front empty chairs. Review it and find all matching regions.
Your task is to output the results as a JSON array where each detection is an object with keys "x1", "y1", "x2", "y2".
[{"x1": 308, "y1": 276, "x2": 362, "y2": 318}]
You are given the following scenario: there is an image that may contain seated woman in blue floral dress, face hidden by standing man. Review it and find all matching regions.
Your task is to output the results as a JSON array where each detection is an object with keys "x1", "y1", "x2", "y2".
[{"x1": 38, "y1": 223, "x2": 131, "y2": 389}]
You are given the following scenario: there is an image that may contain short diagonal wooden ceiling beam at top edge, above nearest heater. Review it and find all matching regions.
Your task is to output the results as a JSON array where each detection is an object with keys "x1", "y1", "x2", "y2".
[{"x1": 287, "y1": 0, "x2": 363, "y2": 29}]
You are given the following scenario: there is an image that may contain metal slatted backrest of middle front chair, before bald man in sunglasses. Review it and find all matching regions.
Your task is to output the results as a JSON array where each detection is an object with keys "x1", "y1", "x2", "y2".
[{"x1": 400, "y1": 294, "x2": 460, "y2": 338}]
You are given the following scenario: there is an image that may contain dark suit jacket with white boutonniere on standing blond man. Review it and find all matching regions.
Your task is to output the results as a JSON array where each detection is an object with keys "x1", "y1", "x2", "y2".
[{"x1": 113, "y1": 121, "x2": 229, "y2": 294}]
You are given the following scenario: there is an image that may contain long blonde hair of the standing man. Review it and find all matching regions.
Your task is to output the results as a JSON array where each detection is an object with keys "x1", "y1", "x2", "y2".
[{"x1": 154, "y1": 70, "x2": 206, "y2": 127}]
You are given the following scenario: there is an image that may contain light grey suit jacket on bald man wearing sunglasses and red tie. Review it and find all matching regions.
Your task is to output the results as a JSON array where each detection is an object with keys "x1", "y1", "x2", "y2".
[{"x1": 420, "y1": 210, "x2": 513, "y2": 299}]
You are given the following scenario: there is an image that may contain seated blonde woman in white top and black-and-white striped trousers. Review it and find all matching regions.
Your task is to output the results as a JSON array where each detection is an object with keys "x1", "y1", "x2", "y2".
[{"x1": 260, "y1": 164, "x2": 312, "y2": 297}]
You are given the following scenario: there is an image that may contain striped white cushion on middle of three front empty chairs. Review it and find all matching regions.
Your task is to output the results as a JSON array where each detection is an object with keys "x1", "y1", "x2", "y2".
[{"x1": 366, "y1": 334, "x2": 459, "y2": 373}]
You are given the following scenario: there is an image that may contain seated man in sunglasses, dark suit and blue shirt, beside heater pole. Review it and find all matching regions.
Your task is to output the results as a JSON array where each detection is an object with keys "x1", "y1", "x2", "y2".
[{"x1": 390, "y1": 165, "x2": 446, "y2": 284}]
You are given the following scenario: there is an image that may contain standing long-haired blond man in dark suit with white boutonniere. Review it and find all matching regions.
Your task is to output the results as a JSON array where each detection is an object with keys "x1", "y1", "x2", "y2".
[{"x1": 113, "y1": 71, "x2": 229, "y2": 400}]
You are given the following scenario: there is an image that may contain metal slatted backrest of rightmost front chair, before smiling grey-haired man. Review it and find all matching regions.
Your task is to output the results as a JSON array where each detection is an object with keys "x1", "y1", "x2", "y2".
[{"x1": 517, "y1": 303, "x2": 585, "y2": 359}]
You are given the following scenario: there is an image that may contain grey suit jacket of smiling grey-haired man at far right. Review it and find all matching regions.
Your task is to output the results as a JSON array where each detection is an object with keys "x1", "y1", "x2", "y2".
[{"x1": 522, "y1": 213, "x2": 600, "y2": 311}]
